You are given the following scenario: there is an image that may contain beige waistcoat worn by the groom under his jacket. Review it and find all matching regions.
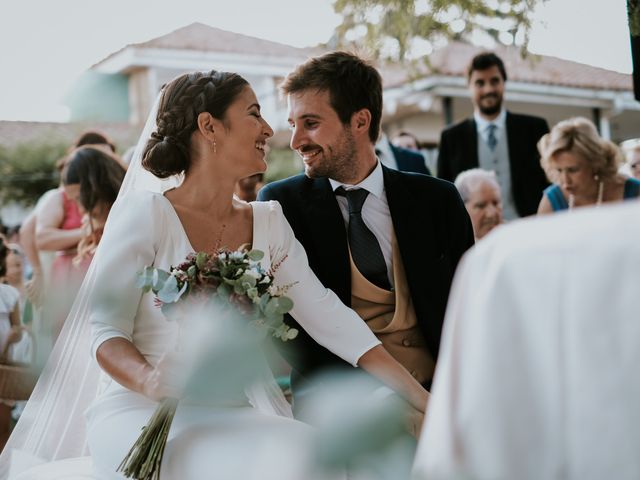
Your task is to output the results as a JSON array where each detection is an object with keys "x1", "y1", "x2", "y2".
[{"x1": 349, "y1": 235, "x2": 435, "y2": 383}]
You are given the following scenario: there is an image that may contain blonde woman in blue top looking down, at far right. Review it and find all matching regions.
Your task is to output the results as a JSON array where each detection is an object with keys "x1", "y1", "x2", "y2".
[{"x1": 538, "y1": 117, "x2": 640, "y2": 214}]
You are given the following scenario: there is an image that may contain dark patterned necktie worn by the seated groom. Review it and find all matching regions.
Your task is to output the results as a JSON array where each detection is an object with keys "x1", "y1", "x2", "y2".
[{"x1": 336, "y1": 187, "x2": 391, "y2": 290}]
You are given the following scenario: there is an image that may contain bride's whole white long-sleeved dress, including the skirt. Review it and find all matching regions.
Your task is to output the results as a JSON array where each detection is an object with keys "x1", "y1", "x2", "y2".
[{"x1": 86, "y1": 191, "x2": 379, "y2": 480}]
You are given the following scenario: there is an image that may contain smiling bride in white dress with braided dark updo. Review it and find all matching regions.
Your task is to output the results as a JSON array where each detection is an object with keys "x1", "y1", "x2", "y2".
[{"x1": 0, "y1": 71, "x2": 428, "y2": 480}]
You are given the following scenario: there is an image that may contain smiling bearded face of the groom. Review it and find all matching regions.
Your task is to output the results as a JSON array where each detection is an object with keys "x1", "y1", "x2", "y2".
[{"x1": 288, "y1": 90, "x2": 356, "y2": 183}]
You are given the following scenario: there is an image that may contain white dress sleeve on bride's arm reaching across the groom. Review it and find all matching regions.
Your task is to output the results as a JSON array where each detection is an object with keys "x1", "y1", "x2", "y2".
[{"x1": 269, "y1": 201, "x2": 380, "y2": 366}]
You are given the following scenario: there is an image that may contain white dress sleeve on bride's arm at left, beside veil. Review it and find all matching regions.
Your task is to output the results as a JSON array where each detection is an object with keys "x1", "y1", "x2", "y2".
[{"x1": 89, "y1": 191, "x2": 163, "y2": 358}]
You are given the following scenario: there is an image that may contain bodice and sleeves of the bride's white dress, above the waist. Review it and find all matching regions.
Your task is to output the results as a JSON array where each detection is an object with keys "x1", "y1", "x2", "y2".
[{"x1": 90, "y1": 192, "x2": 380, "y2": 372}]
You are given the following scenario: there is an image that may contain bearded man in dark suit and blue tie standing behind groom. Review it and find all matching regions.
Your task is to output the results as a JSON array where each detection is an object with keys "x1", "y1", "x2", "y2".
[{"x1": 437, "y1": 52, "x2": 549, "y2": 220}]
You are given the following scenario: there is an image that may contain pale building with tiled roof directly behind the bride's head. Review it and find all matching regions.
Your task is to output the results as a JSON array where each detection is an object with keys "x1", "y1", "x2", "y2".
[{"x1": 91, "y1": 23, "x2": 320, "y2": 143}]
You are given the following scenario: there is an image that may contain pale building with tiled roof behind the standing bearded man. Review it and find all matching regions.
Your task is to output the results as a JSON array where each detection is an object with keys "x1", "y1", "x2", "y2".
[{"x1": 383, "y1": 42, "x2": 640, "y2": 145}]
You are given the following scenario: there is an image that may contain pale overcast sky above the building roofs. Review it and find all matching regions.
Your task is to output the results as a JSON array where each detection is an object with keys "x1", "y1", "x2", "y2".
[{"x1": 0, "y1": 0, "x2": 632, "y2": 121}]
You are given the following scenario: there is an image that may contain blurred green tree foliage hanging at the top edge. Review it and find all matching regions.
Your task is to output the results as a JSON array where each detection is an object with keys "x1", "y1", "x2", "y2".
[{"x1": 334, "y1": 0, "x2": 548, "y2": 61}]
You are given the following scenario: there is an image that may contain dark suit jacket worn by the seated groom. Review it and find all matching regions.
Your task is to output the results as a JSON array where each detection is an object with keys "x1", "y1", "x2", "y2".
[{"x1": 258, "y1": 166, "x2": 473, "y2": 408}]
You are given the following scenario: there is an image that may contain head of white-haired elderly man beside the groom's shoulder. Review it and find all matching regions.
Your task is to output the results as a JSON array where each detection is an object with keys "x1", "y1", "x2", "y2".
[{"x1": 455, "y1": 168, "x2": 502, "y2": 241}]
